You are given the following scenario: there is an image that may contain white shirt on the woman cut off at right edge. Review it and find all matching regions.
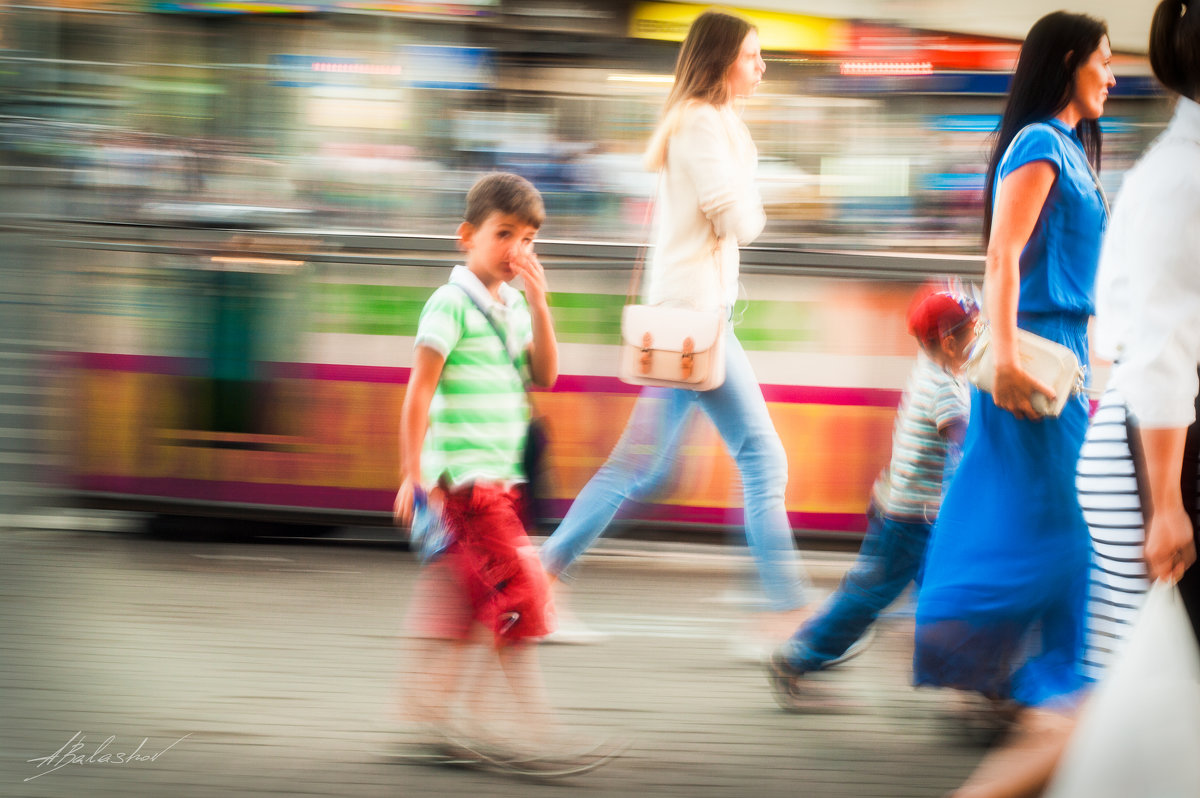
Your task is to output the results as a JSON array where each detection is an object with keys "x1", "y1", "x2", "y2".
[{"x1": 1094, "y1": 97, "x2": 1200, "y2": 427}]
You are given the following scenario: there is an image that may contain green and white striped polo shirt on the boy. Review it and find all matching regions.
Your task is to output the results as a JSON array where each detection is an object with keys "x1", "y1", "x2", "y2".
[{"x1": 415, "y1": 266, "x2": 533, "y2": 485}]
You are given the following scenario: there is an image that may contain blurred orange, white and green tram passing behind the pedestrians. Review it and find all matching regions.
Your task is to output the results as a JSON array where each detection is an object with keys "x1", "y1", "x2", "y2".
[{"x1": 54, "y1": 224, "x2": 982, "y2": 538}]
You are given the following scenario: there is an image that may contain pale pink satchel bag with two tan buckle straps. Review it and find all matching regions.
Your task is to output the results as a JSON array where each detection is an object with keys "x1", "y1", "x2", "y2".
[{"x1": 618, "y1": 305, "x2": 725, "y2": 391}]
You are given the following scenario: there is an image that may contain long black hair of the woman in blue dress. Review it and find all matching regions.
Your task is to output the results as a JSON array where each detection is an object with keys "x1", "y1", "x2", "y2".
[{"x1": 983, "y1": 11, "x2": 1109, "y2": 245}]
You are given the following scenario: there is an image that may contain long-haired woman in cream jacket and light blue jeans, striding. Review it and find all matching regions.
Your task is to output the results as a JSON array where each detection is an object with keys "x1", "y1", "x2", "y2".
[{"x1": 541, "y1": 11, "x2": 806, "y2": 635}]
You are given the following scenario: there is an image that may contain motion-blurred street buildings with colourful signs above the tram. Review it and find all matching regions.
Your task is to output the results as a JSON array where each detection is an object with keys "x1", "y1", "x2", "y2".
[{"x1": 0, "y1": 0, "x2": 1166, "y2": 251}]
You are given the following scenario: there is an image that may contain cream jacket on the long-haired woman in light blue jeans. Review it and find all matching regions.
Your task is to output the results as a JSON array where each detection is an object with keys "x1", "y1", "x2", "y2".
[{"x1": 646, "y1": 102, "x2": 767, "y2": 310}]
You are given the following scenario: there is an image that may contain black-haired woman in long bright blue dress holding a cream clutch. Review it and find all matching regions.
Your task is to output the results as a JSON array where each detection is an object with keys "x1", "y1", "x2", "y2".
[{"x1": 913, "y1": 12, "x2": 1116, "y2": 710}]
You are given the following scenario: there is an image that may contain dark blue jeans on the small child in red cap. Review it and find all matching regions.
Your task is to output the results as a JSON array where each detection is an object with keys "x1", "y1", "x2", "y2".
[{"x1": 784, "y1": 508, "x2": 932, "y2": 671}]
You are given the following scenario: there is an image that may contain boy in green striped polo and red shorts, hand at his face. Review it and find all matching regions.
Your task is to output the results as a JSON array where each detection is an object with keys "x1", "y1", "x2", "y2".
[{"x1": 394, "y1": 174, "x2": 558, "y2": 762}]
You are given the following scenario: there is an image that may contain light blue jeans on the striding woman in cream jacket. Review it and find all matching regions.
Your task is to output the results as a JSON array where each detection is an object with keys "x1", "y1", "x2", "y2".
[{"x1": 541, "y1": 330, "x2": 805, "y2": 610}]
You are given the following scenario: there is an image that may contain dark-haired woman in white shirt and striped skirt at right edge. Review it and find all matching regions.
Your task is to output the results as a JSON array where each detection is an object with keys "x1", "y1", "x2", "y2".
[{"x1": 1078, "y1": 0, "x2": 1200, "y2": 678}]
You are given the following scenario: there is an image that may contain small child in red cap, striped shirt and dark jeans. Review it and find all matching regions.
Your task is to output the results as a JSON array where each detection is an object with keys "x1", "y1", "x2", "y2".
[{"x1": 767, "y1": 284, "x2": 978, "y2": 710}]
